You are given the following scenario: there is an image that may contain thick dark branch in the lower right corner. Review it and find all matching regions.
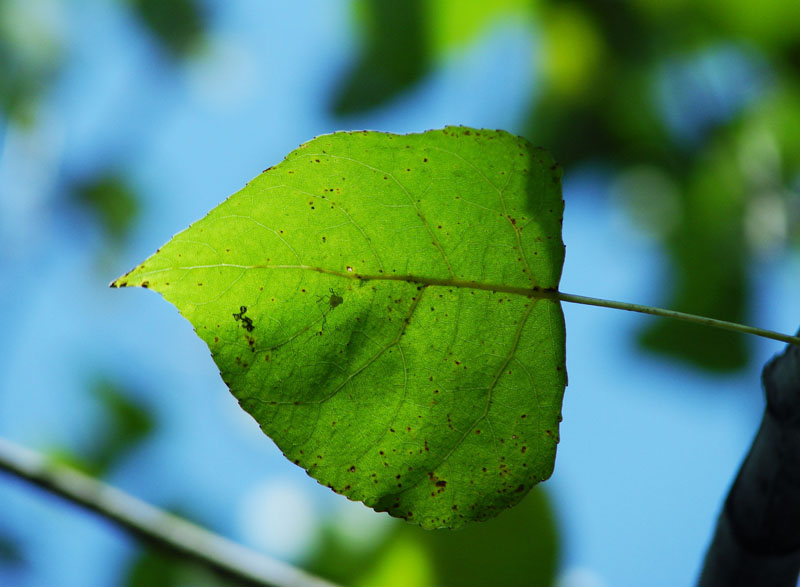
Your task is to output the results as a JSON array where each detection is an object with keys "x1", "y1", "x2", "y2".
[{"x1": 699, "y1": 338, "x2": 800, "y2": 587}]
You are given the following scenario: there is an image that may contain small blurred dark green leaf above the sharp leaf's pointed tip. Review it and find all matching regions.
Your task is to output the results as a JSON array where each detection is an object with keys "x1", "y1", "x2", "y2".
[{"x1": 71, "y1": 173, "x2": 139, "y2": 244}]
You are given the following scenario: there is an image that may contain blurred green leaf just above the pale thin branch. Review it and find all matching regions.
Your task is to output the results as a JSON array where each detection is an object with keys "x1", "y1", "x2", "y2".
[{"x1": 52, "y1": 379, "x2": 154, "y2": 477}]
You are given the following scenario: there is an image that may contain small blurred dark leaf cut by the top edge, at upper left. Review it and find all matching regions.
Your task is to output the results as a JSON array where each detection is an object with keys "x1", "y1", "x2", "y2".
[{"x1": 128, "y1": 0, "x2": 206, "y2": 57}]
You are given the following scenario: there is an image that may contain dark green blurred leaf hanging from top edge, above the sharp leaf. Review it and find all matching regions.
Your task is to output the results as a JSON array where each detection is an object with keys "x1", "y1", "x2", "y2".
[{"x1": 332, "y1": 0, "x2": 431, "y2": 116}]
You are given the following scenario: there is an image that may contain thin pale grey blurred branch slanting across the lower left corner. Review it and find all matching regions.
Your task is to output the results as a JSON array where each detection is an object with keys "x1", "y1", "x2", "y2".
[{"x1": 0, "y1": 438, "x2": 331, "y2": 587}]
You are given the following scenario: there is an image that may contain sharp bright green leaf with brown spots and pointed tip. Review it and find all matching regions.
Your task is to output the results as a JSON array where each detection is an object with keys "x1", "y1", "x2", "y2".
[{"x1": 112, "y1": 127, "x2": 566, "y2": 528}]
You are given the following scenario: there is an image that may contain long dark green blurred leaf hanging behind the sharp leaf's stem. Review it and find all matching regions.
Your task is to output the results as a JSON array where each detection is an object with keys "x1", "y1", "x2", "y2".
[{"x1": 641, "y1": 149, "x2": 749, "y2": 371}]
